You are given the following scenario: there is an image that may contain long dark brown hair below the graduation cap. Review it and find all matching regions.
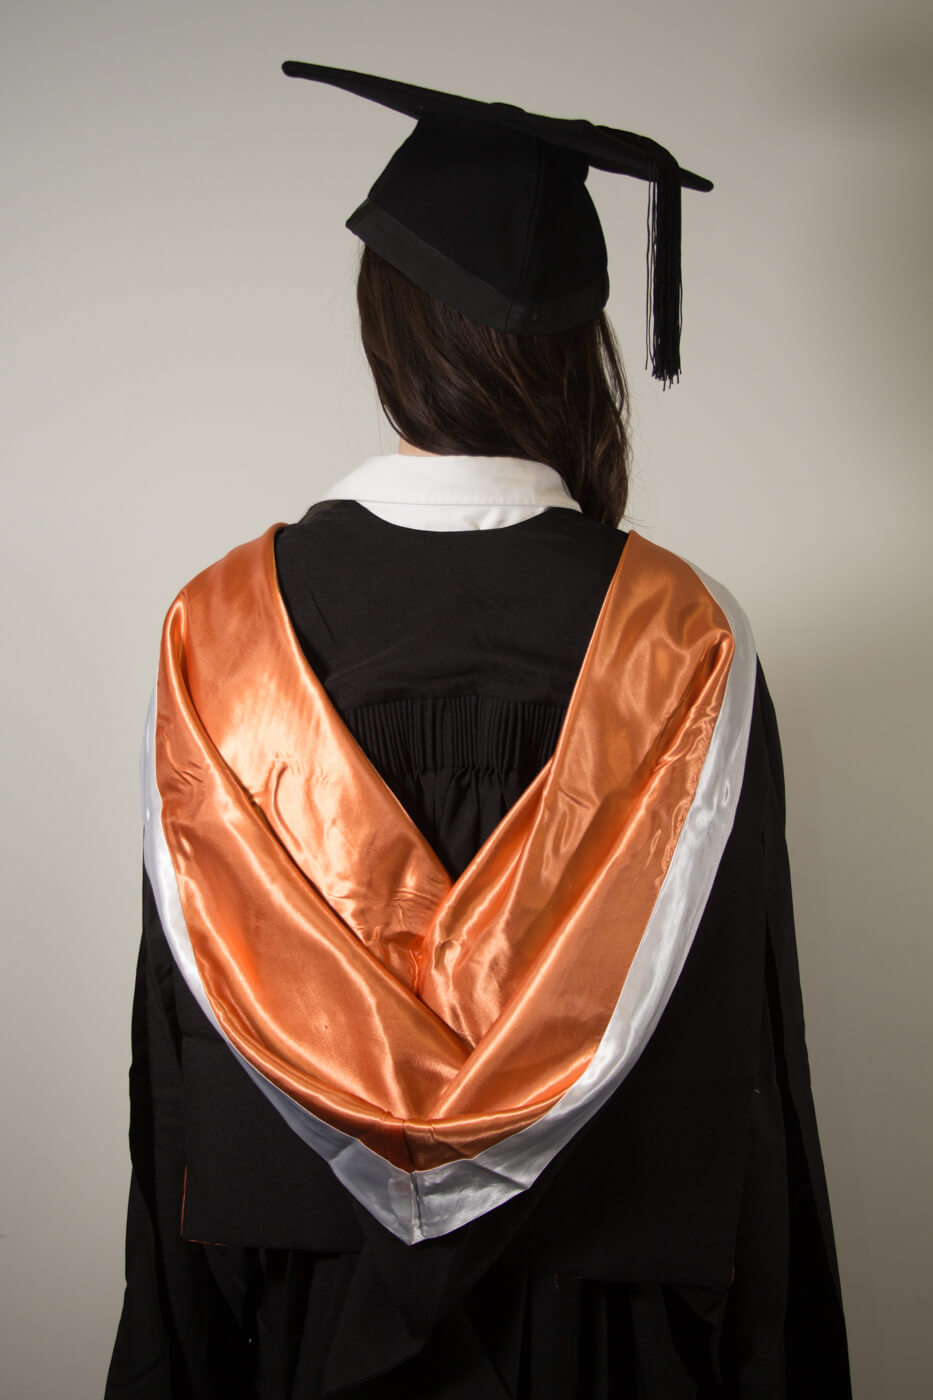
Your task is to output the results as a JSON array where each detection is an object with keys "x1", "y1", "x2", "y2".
[{"x1": 357, "y1": 246, "x2": 630, "y2": 525}]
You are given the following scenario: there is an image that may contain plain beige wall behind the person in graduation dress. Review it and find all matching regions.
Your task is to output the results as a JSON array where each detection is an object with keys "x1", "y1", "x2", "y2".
[{"x1": 0, "y1": 0, "x2": 933, "y2": 1400}]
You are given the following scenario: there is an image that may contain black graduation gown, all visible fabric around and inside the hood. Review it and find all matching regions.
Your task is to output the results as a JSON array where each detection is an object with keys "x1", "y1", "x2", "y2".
[{"x1": 106, "y1": 501, "x2": 850, "y2": 1400}]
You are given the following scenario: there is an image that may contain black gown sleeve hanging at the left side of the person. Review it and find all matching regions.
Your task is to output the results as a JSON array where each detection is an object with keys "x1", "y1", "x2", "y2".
[{"x1": 105, "y1": 878, "x2": 252, "y2": 1400}]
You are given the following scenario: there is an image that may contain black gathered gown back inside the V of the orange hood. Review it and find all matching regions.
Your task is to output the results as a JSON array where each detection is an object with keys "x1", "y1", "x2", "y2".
[{"x1": 276, "y1": 501, "x2": 626, "y2": 878}]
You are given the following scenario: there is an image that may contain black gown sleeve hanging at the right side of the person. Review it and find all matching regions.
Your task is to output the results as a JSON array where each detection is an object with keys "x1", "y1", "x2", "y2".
[{"x1": 711, "y1": 665, "x2": 852, "y2": 1400}]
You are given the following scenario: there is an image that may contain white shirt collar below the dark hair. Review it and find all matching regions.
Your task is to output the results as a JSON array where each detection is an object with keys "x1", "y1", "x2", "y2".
[{"x1": 319, "y1": 452, "x2": 580, "y2": 531}]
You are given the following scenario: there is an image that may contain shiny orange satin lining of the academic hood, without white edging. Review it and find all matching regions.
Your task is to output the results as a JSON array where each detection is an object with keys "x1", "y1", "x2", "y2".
[{"x1": 156, "y1": 525, "x2": 733, "y2": 1170}]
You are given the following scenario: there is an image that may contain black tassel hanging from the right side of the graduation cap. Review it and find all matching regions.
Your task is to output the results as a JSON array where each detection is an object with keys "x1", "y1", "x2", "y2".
[{"x1": 646, "y1": 151, "x2": 682, "y2": 388}]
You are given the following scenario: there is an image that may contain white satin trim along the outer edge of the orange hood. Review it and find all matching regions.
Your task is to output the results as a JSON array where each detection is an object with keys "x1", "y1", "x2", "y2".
[{"x1": 140, "y1": 551, "x2": 756, "y2": 1245}]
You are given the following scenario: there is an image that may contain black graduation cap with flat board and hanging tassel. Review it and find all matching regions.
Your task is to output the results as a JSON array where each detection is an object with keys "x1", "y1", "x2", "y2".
[{"x1": 282, "y1": 62, "x2": 713, "y2": 384}]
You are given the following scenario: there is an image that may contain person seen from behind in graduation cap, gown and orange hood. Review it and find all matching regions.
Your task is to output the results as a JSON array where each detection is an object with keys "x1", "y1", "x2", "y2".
[{"x1": 108, "y1": 57, "x2": 849, "y2": 1400}]
